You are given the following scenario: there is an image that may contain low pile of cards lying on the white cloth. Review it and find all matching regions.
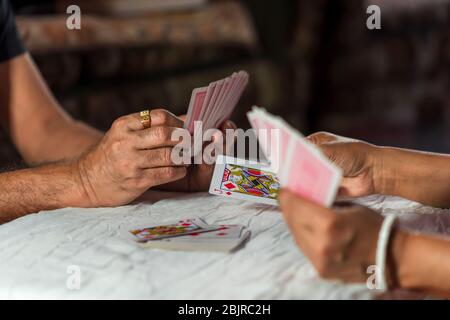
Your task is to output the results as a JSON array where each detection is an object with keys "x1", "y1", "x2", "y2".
[{"x1": 124, "y1": 218, "x2": 250, "y2": 252}]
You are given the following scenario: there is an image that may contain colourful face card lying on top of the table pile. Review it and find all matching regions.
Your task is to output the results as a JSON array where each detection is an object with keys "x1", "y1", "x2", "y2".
[{"x1": 127, "y1": 218, "x2": 218, "y2": 242}]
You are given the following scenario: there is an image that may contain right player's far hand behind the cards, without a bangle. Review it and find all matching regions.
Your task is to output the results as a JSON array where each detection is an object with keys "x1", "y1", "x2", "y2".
[{"x1": 308, "y1": 132, "x2": 381, "y2": 197}]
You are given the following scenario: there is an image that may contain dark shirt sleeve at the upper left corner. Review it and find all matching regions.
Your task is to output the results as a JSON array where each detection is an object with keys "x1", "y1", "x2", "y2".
[{"x1": 0, "y1": 0, "x2": 25, "y2": 62}]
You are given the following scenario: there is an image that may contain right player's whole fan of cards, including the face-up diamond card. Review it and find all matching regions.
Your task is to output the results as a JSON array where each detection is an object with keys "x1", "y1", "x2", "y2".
[{"x1": 209, "y1": 107, "x2": 342, "y2": 206}]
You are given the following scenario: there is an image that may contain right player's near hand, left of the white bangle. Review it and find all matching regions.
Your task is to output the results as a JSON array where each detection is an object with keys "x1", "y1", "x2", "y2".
[{"x1": 279, "y1": 190, "x2": 383, "y2": 282}]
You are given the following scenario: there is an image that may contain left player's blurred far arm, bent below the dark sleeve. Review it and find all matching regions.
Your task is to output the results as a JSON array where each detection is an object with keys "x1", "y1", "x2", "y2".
[{"x1": 0, "y1": 54, "x2": 102, "y2": 164}]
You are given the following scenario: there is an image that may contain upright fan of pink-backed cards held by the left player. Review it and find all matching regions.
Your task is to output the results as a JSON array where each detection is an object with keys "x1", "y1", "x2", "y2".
[{"x1": 184, "y1": 71, "x2": 249, "y2": 134}]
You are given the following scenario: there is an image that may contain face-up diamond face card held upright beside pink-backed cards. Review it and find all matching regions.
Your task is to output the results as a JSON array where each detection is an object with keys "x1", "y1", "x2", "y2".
[{"x1": 209, "y1": 155, "x2": 280, "y2": 205}]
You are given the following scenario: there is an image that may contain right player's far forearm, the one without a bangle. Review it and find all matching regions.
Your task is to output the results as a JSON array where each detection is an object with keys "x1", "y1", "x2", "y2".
[{"x1": 375, "y1": 147, "x2": 450, "y2": 208}]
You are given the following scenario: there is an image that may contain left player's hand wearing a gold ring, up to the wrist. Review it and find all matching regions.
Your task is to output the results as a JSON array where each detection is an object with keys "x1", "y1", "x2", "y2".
[{"x1": 79, "y1": 109, "x2": 187, "y2": 206}]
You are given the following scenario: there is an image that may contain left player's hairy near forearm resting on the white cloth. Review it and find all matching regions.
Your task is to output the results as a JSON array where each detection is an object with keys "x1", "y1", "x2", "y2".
[{"x1": 0, "y1": 162, "x2": 89, "y2": 224}]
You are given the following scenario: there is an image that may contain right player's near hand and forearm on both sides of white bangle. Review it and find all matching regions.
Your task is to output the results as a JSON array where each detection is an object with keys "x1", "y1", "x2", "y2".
[{"x1": 279, "y1": 190, "x2": 450, "y2": 298}]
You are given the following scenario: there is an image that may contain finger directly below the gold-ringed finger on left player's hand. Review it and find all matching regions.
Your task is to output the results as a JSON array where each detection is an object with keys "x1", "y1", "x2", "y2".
[{"x1": 134, "y1": 126, "x2": 188, "y2": 149}]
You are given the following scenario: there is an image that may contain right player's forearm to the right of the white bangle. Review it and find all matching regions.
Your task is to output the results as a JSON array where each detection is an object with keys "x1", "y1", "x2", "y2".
[{"x1": 391, "y1": 230, "x2": 450, "y2": 298}]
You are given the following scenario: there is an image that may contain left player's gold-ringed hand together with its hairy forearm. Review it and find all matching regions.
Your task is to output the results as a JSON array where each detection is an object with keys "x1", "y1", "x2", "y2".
[{"x1": 0, "y1": 110, "x2": 232, "y2": 224}]
